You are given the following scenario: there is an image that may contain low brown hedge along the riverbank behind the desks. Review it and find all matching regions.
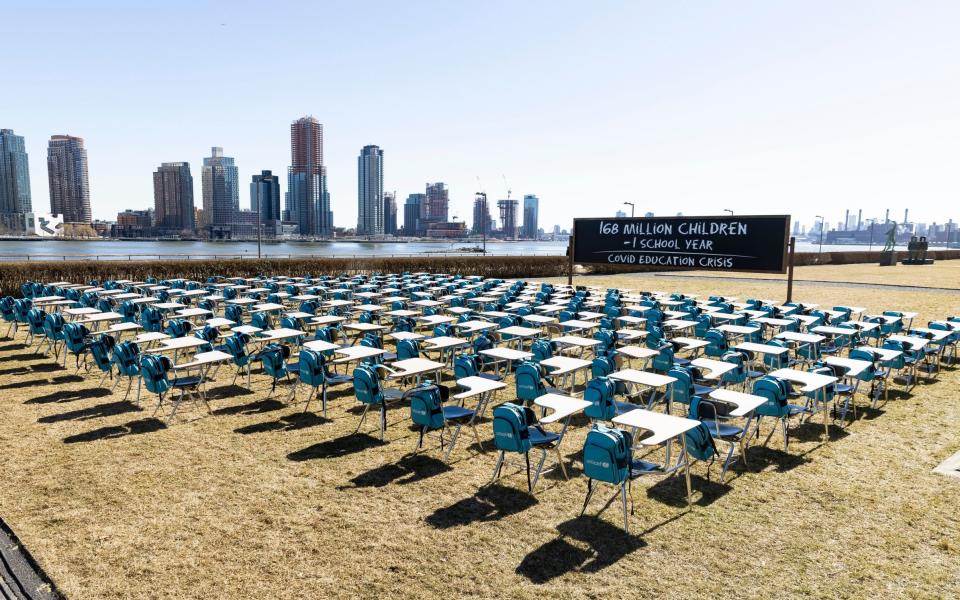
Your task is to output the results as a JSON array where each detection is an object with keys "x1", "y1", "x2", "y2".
[{"x1": 0, "y1": 250, "x2": 960, "y2": 296}]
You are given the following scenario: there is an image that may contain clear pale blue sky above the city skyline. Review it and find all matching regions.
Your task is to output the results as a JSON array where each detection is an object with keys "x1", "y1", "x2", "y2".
[{"x1": 0, "y1": 0, "x2": 960, "y2": 228}]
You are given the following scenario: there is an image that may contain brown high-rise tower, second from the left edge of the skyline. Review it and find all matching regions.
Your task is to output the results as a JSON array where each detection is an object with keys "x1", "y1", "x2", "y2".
[{"x1": 47, "y1": 135, "x2": 93, "y2": 224}]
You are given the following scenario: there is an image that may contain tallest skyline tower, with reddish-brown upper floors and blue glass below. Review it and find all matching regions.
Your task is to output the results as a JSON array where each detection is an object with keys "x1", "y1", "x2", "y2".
[{"x1": 286, "y1": 117, "x2": 333, "y2": 237}]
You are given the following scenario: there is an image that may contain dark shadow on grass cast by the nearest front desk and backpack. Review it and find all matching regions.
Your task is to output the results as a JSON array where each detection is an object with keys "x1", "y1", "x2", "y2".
[{"x1": 516, "y1": 515, "x2": 648, "y2": 584}]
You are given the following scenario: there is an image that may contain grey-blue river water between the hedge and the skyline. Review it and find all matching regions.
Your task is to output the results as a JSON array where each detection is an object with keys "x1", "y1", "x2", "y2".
[{"x1": 0, "y1": 240, "x2": 908, "y2": 261}]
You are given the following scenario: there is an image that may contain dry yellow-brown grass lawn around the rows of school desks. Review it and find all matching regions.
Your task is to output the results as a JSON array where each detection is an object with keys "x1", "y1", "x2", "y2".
[{"x1": 0, "y1": 261, "x2": 960, "y2": 599}]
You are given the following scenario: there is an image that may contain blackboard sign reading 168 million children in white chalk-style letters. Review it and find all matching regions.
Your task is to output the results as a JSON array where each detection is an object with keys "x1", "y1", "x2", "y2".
[{"x1": 573, "y1": 215, "x2": 790, "y2": 273}]
